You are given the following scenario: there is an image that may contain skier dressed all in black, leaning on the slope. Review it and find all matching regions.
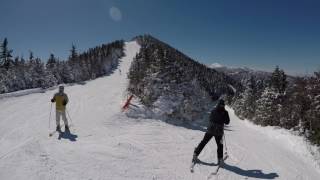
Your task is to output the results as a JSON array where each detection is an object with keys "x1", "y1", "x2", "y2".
[{"x1": 192, "y1": 99, "x2": 230, "y2": 164}]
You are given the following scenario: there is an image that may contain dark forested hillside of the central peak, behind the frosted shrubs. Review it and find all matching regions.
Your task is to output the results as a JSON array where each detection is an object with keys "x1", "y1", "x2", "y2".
[{"x1": 129, "y1": 35, "x2": 237, "y2": 104}]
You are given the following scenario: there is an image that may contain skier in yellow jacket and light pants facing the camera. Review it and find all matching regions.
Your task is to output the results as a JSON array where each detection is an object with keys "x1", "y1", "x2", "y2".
[{"x1": 51, "y1": 86, "x2": 69, "y2": 131}]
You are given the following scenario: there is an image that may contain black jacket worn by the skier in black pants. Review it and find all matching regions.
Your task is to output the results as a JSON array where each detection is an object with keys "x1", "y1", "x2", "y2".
[{"x1": 207, "y1": 108, "x2": 230, "y2": 136}]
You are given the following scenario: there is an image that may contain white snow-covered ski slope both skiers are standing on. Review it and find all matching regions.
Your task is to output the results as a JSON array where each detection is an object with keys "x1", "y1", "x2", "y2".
[{"x1": 0, "y1": 41, "x2": 320, "y2": 180}]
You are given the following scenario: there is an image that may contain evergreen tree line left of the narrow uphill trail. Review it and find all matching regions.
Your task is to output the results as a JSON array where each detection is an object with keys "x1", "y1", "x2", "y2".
[{"x1": 0, "y1": 38, "x2": 124, "y2": 93}]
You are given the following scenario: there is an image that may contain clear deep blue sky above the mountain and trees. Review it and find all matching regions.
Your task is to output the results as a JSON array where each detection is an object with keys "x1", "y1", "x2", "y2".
[{"x1": 0, "y1": 0, "x2": 320, "y2": 75}]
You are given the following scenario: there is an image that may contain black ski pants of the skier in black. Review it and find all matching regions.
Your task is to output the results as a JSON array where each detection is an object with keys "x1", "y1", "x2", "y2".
[{"x1": 194, "y1": 133, "x2": 223, "y2": 159}]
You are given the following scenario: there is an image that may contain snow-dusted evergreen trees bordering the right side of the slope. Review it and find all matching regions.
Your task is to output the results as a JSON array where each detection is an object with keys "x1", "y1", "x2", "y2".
[{"x1": 229, "y1": 66, "x2": 320, "y2": 145}]
